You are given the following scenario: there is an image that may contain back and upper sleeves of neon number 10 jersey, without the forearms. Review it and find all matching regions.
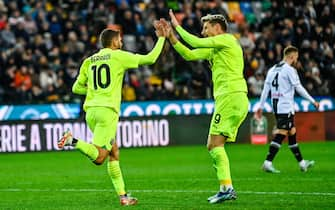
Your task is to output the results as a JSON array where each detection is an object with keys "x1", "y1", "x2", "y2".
[{"x1": 81, "y1": 48, "x2": 138, "y2": 112}]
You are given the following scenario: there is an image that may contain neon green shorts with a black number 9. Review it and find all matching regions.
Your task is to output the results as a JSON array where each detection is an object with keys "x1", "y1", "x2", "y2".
[{"x1": 209, "y1": 92, "x2": 249, "y2": 142}]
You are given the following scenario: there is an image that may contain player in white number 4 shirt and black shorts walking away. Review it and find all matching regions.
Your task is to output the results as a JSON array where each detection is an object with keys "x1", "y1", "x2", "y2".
[{"x1": 257, "y1": 46, "x2": 319, "y2": 173}]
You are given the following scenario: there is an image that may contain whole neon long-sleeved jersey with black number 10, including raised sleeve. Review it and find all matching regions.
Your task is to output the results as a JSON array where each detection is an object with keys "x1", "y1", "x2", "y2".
[{"x1": 72, "y1": 37, "x2": 165, "y2": 113}]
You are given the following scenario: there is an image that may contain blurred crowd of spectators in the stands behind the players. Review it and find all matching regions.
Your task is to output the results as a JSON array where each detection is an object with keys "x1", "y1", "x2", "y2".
[{"x1": 0, "y1": 0, "x2": 335, "y2": 104}]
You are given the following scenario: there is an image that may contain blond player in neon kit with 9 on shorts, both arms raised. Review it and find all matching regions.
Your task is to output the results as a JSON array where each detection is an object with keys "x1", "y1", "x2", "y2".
[{"x1": 160, "y1": 10, "x2": 249, "y2": 203}]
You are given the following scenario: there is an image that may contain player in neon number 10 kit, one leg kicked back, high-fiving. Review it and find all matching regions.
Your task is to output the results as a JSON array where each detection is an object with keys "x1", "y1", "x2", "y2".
[{"x1": 58, "y1": 22, "x2": 167, "y2": 205}]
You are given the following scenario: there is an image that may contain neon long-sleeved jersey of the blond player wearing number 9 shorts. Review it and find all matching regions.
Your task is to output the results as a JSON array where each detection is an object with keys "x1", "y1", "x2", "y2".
[{"x1": 174, "y1": 26, "x2": 248, "y2": 98}]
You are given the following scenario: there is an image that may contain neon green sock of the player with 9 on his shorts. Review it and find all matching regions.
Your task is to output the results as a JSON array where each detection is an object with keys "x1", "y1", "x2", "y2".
[{"x1": 209, "y1": 147, "x2": 232, "y2": 187}]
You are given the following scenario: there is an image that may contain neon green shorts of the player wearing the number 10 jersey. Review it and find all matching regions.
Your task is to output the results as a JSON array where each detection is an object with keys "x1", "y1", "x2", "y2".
[{"x1": 86, "y1": 107, "x2": 119, "y2": 151}]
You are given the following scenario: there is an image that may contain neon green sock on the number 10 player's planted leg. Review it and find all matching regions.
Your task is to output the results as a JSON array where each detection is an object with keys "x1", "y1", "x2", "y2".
[{"x1": 107, "y1": 160, "x2": 126, "y2": 195}]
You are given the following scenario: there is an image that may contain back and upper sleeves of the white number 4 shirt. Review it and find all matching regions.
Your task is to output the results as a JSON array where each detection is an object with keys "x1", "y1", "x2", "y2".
[{"x1": 265, "y1": 61, "x2": 298, "y2": 114}]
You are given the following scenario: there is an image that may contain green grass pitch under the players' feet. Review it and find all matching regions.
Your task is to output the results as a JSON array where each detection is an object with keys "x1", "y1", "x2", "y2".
[{"x1": 0, "y1": 141, "x2": 335, "y2": 210}]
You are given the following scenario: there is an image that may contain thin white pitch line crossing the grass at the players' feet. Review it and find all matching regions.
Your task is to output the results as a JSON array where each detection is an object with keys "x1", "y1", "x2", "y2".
[{"x1": 0, "y1": 188, "x2": 335, "y2": 196}]
